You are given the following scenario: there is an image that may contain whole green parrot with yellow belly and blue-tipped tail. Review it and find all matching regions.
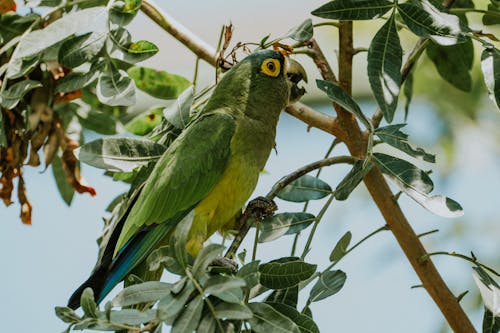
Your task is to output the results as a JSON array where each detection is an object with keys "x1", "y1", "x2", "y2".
[{"x1": 68, "y1": 49, "x2": 307, "y2": 309}]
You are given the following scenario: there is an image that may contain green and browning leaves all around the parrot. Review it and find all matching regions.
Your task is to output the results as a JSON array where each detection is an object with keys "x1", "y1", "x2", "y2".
[{"x1": 0, "y1": 0, "x2": 500, "y2": 332}]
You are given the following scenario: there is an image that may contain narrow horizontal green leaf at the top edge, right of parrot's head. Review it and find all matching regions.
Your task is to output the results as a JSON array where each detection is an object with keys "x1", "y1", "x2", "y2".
[{"x1": 311, "y1": 0, "x2": 394, "y2": 20}]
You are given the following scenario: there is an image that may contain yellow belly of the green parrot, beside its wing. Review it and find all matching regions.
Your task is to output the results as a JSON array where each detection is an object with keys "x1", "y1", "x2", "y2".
[{"x1": 187, "y1": 156, "x2": 260, "y2": 255}]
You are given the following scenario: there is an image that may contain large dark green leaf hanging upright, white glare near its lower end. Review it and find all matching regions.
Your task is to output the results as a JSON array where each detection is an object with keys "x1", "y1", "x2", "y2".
[{"x1": 368, "y1": 13, "x2": 403, "y2": 123}]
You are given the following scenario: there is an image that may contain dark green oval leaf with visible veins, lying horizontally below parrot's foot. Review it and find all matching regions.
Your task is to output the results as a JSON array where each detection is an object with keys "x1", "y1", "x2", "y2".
[{"x1": 259, "y1": 257, "x2": 317, "y2": 289}]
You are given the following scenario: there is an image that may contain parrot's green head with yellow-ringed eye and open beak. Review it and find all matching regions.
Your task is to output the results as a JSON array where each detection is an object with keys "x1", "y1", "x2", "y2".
[{"x1": 212, "y1": 50, "x2": 307, "y2": 122}]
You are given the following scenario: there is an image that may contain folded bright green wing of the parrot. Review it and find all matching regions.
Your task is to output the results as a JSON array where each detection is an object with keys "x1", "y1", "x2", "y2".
[{"x1": 115, "y1": 110, "x2": 236, "y2": 255}]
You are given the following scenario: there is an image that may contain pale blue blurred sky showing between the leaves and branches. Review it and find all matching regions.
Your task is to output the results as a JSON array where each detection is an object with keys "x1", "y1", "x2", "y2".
[{"x1": 0, "y1": 0, "x2": 500, "y2": 333}]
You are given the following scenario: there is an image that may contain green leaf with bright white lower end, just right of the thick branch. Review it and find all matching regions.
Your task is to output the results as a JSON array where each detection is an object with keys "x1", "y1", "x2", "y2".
[{"x1": 373, "y1": 153, "x2": 463, "y2": 217}]
